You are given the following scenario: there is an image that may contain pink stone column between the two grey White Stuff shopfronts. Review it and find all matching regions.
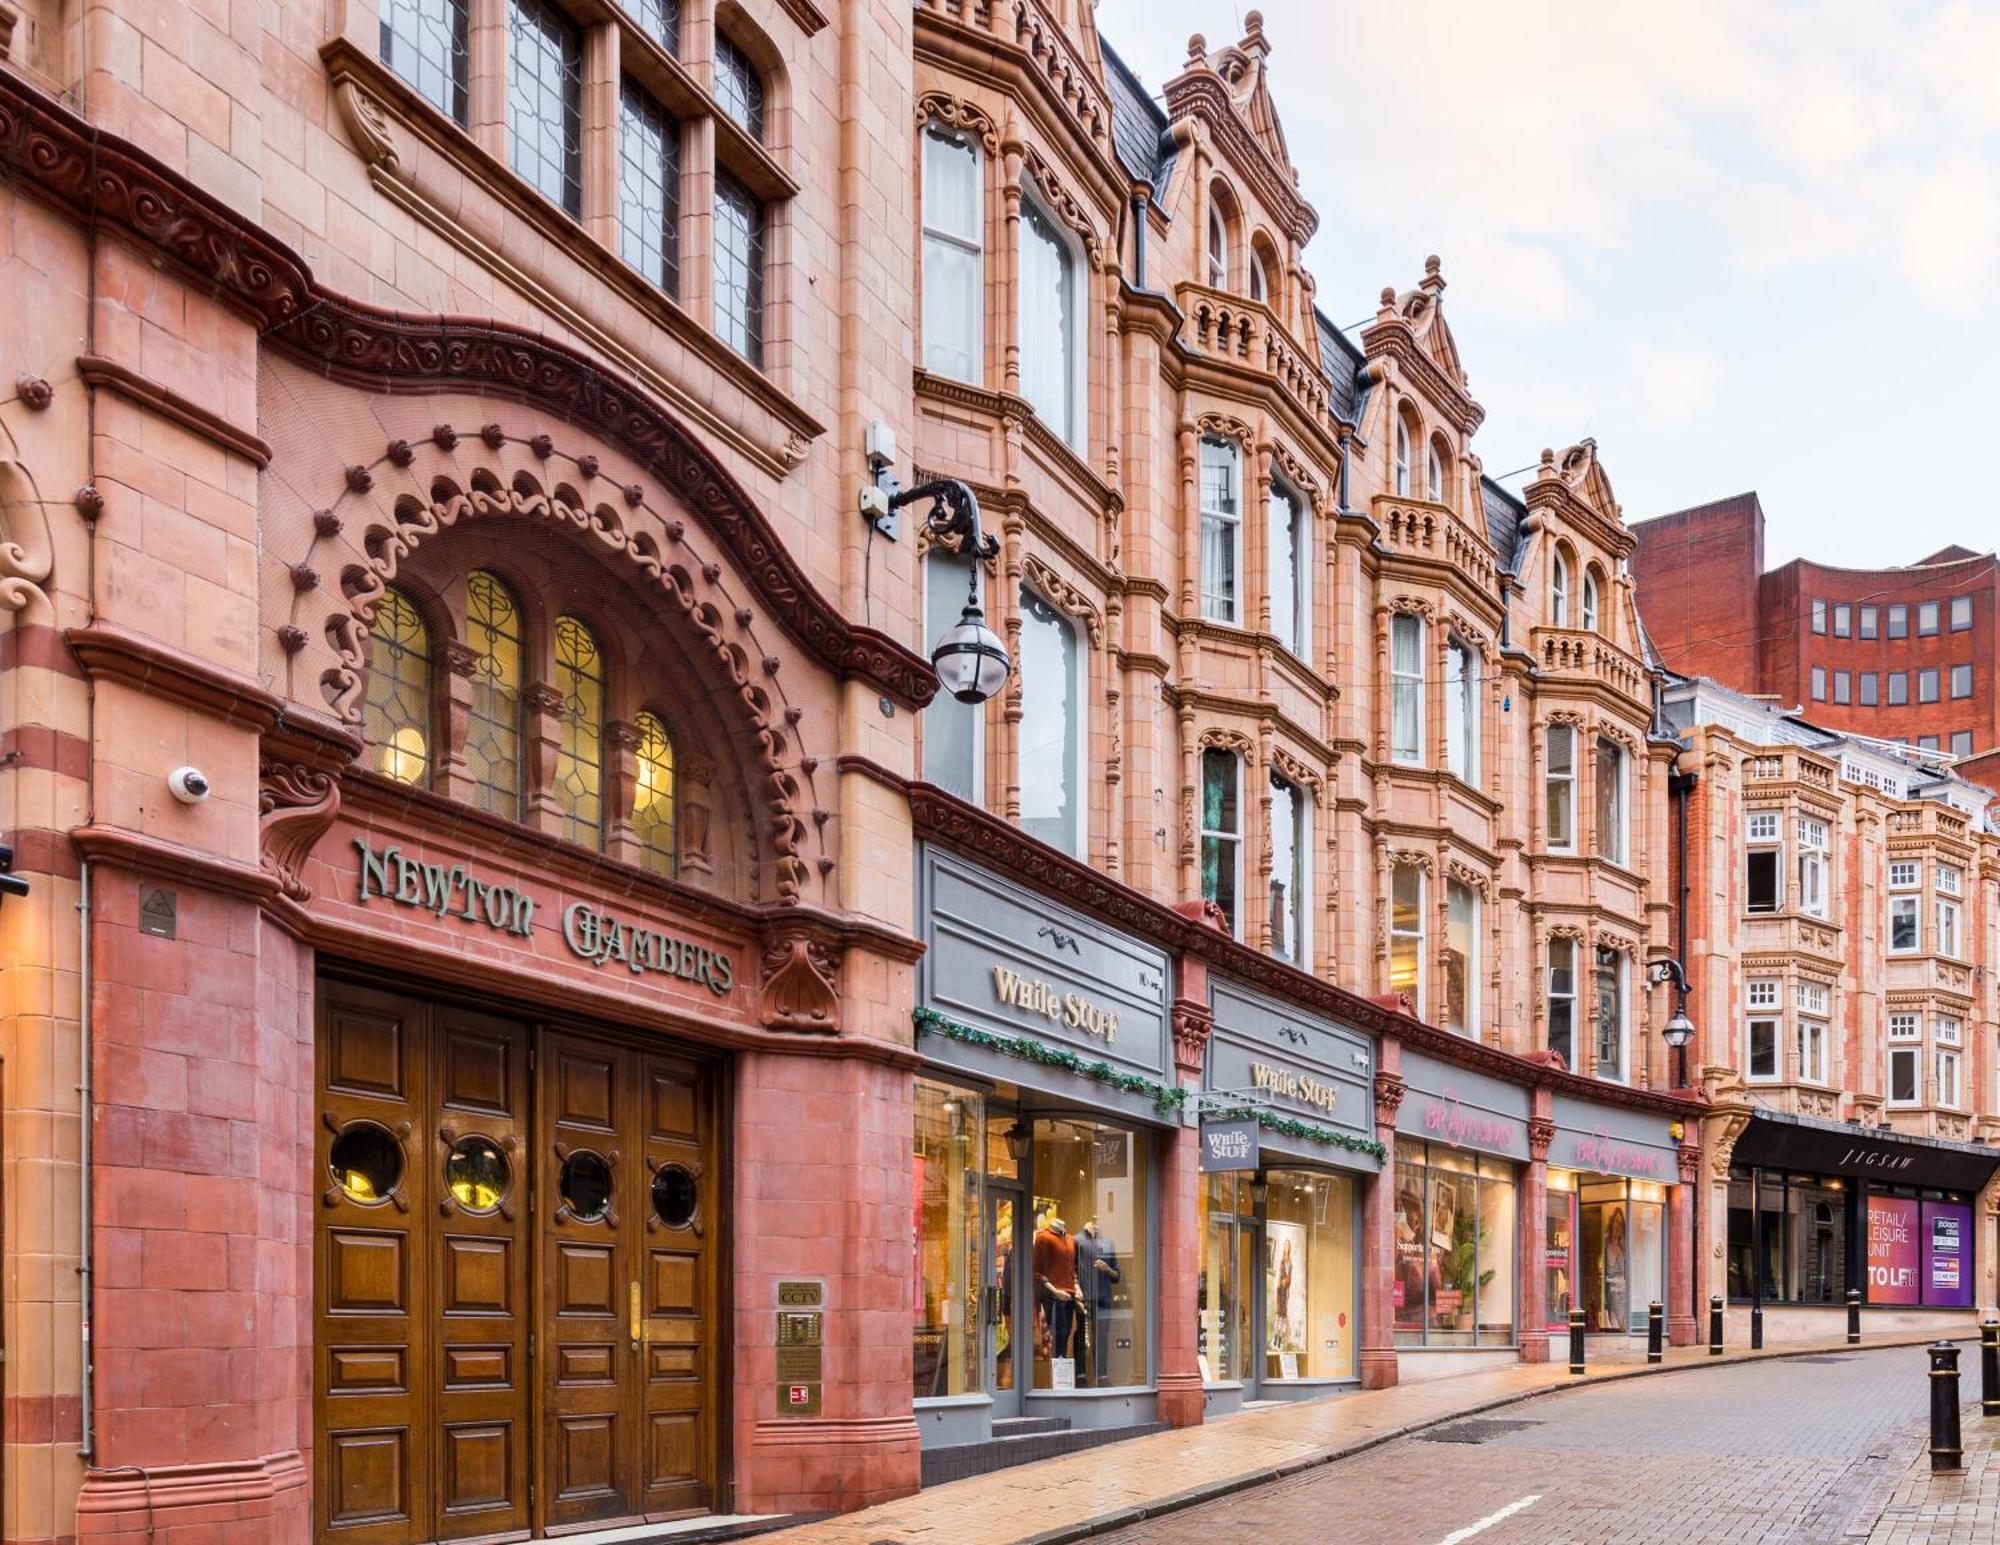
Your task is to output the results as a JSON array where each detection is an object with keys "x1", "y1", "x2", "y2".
[{"x1": 1154, "y1": 972, "x2": 1214, "y2": 1427}]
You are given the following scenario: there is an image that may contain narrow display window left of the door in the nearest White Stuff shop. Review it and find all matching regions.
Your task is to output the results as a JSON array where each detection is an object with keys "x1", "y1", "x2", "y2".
[{"x1": 910, "y1": 1079, "x2": 986, "y2": 1401}]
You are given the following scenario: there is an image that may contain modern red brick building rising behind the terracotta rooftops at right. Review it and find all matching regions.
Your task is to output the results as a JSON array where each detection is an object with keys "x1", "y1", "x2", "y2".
[{"x1": 1632, "y1": 492, "x2": 2000, "y2": 756}]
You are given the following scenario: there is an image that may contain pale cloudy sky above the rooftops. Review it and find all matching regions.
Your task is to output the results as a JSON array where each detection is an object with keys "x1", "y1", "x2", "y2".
[{"x1": 1098, "y1": 0, "x2": 2000, "y2": 566}]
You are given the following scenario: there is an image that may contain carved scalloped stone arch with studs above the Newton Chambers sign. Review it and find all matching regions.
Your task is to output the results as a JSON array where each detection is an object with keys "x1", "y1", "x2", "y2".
[{"x1": 302, "y1": 444, "x2": 812, "y2": 905}]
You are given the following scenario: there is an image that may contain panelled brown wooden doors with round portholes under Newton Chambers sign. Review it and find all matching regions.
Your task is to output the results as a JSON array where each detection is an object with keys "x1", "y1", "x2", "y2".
[{"x1": 314, "y1": 979, "x2": 722, "y2": 1545}]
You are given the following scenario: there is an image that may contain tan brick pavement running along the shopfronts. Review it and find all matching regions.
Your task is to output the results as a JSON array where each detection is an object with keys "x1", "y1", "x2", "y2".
[{"x1": 770, "y1": 1321, "x2": 1972, "y2": 1545}]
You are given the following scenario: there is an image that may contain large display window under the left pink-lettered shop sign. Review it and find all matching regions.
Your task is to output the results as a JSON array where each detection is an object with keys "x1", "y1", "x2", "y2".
[{"x1": 1392, "y1": 1141, "x2": 1518, "y2": 1347}]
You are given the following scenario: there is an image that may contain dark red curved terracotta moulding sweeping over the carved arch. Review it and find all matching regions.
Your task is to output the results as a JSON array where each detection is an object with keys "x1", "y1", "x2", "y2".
[{"x1": 0, "y1": 70, "x2": 938, "y2": 708}]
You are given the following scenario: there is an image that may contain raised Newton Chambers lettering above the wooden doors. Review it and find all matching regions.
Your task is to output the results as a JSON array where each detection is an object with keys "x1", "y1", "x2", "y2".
[{"x1": 354, "y1": 837, "x2": 736, "y2": 997}]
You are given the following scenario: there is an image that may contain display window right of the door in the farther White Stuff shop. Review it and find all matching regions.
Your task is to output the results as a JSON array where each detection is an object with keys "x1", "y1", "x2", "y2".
[{"x1": 1264, "y1": 1169, "x2": 1356, "y2": 1379}]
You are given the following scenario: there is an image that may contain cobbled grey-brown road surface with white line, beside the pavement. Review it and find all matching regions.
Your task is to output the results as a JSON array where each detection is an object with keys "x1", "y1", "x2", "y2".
[{"x1": 1104, "y1": 1349, "x2": 1968, "y2": 1545}]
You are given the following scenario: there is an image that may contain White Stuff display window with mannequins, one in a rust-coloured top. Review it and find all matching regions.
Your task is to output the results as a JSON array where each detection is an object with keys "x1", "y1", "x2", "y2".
[{"x1": 1032, "y1": 1119, "x2": 1152, "y2": 1391}]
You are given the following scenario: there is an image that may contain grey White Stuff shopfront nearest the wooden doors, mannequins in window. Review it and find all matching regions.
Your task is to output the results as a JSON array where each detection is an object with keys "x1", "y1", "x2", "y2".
[{"x1": 910, "y1": 845, "x2": 1182, "y2": 1449}]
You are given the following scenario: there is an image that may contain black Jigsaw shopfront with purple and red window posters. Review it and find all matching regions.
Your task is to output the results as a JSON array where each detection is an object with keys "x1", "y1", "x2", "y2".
[{"x1": 1728, "y1": 1111, "x2": 2000, "y2": 1311}]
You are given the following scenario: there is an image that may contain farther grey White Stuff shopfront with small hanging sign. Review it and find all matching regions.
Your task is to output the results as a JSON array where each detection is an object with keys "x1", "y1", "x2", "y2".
[{"x1": 1196, "y1": 979, "x2": 1382, "y2": 1415}]
